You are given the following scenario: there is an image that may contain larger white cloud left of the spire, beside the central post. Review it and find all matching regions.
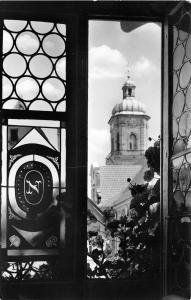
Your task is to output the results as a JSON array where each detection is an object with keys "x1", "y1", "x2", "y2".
[{"x1": 89, "y1": 45, "x2": 127, "y2": 79}]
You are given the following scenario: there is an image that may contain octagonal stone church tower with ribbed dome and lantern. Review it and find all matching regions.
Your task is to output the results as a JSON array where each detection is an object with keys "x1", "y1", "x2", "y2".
[{"x1": 106, "y1": 75, "x2": 150, "y2": 165}]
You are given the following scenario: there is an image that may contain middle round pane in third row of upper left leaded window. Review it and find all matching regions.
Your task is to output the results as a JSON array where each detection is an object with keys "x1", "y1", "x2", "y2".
[{"x1": 29, "y1": 54, "x2": 53, "y2": 78}]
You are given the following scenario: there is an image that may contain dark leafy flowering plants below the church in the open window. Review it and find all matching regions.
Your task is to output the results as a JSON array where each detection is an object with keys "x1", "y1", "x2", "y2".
[{"x1": 87, "y1": 139, "x2": 160, "y2": 279}]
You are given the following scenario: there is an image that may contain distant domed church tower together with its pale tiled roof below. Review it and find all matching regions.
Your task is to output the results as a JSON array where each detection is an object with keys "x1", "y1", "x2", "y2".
[{"x1": 90, "y1": 76, "x2": 150, "y2": 218}]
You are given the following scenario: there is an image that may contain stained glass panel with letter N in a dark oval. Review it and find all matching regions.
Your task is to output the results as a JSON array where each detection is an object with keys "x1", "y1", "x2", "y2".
[{"x1": 1, "y1": 119, "x2": 65, "y2": 256}]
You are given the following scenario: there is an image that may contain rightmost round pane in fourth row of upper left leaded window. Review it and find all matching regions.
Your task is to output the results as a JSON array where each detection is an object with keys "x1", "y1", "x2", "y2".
[{"x1": 42, "y1": 78, "x2": 65, "y2": 101}]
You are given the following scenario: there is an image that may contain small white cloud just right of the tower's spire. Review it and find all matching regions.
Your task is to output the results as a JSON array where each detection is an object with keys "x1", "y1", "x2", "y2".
[{"x1": 131, "y1": 56, "x2": 156, "y2": 77}]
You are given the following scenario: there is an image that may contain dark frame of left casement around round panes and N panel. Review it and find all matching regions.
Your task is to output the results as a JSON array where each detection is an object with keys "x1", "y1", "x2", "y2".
[{"x1": 0, "y1": 3, "x2": 78, "y2": 287}]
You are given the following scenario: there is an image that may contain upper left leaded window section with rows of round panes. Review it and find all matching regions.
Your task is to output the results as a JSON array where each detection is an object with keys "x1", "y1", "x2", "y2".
[{"x1": 2, "y1": 20, "x2": 66, "y2": 112}]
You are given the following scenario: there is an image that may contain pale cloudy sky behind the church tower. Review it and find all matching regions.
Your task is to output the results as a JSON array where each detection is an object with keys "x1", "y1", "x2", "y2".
[{"x1": 88, "y1": 20, "x2": 161, "y2": 172}]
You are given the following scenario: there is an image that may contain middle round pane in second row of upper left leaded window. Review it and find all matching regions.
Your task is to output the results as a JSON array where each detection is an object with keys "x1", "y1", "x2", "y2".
[{"x1": 16, "y1": 31, "x2": 40, "y2": 55}]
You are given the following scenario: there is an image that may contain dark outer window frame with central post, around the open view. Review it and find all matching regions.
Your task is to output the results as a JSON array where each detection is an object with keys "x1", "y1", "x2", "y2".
[{"x1": 0, "y1": 1, "x2": 185, "y2": 299}]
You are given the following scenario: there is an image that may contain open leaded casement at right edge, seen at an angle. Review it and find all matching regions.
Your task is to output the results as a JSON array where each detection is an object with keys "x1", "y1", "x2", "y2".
[{"x1": 167, "y1": 7, "x2": 191, "y2": 298}]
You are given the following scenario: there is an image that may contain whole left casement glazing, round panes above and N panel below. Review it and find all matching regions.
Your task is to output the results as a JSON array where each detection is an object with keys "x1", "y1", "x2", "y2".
[{"x1": 1, "y1": 19, "x2": 67, "y2": 260}]
